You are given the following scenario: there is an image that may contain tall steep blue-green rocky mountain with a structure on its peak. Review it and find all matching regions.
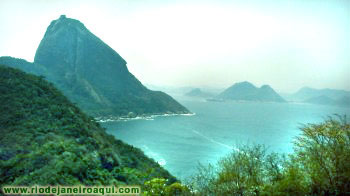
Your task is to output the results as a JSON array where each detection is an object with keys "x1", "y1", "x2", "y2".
[{"x1": 0, "y1": 15, "x2": 189, "y2": 116}]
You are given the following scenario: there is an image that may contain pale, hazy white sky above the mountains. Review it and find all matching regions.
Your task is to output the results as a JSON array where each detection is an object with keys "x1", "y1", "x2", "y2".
[{"x1": 0, "y1": 0, "x2": 350, "y2": 92}]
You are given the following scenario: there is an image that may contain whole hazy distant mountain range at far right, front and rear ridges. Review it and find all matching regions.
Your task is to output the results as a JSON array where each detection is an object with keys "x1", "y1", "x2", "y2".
[{"x1": 285, "y1": 87, "x2": 350, "y2": 107}]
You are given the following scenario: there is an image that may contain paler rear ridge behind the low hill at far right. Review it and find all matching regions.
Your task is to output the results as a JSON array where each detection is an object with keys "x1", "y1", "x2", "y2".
[{"x1": 288, "y1": 87, "x2": 350, "y2": 102}]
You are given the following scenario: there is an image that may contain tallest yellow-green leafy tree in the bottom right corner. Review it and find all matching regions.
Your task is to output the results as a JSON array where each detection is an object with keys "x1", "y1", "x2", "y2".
[{"x1": 295, "y1": 116, "x2": 350, "y2": 195}]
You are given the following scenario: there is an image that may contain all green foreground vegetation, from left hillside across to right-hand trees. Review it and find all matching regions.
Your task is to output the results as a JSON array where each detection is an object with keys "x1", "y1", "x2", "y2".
[{"x1": 0, "y1": 63, "x2": 350, "y2": 196}]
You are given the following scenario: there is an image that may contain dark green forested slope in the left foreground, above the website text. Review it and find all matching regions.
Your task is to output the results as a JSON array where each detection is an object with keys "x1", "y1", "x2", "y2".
[{"x1": 0, "y1": 65, "x2": 176, "y2": 186}]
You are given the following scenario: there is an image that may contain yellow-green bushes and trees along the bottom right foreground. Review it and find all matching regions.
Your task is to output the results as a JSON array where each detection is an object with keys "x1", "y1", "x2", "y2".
[{"x1": 146, "y1": 117, "x2": 350, "y2": 196}]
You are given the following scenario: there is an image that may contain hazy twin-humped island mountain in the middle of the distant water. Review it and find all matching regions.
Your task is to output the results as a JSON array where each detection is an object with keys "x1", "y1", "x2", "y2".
[{"x1": 217, "y1": 82, "x2": 285, "y2": 102}]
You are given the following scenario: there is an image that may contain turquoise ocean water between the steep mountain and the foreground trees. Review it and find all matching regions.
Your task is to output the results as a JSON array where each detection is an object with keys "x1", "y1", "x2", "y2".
[{"x1": 102, "y1": 100, "x2": 350, "y2": 179}]
